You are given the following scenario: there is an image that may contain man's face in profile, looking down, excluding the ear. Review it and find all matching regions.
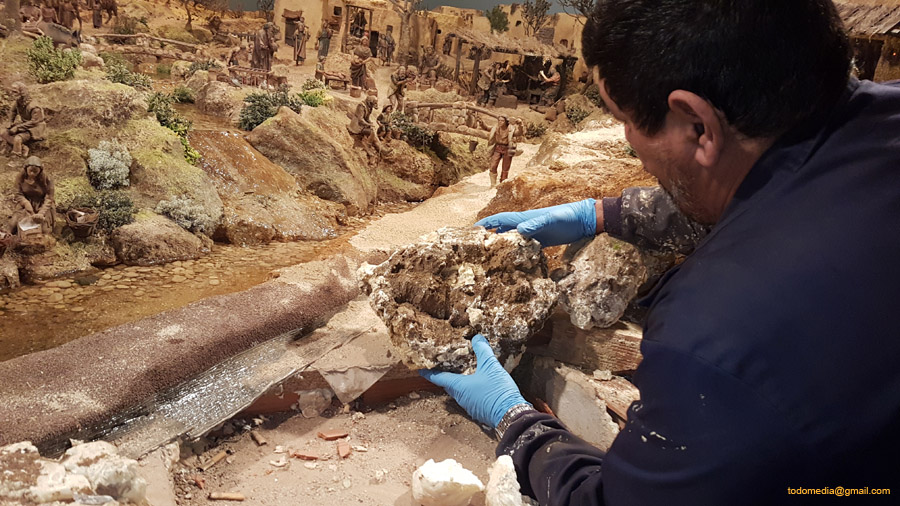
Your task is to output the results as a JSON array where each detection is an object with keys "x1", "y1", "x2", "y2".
[{"x1": 594, "y1": 76, "x2": 708, "y2": 221}]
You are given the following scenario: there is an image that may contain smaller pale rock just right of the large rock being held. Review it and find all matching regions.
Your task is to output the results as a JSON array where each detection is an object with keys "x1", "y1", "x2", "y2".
[{"x1": 559, "y1": 234, "x2": 647, "y2": 330}]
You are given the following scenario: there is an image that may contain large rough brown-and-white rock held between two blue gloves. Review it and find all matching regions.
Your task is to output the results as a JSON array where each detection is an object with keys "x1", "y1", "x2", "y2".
[{"x1": 359, "y1": 227, "x2": 558, "y2": 372}]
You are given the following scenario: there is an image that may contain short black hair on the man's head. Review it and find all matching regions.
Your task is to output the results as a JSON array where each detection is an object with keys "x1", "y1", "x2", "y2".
[{"x1": 582, "y1": 0, "x2": 851, "y2": 137}]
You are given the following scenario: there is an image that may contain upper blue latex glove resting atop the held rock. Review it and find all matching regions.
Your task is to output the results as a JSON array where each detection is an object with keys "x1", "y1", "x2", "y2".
[{"x1": 475, "y1": 199, "x2": 597, "y2": 247}]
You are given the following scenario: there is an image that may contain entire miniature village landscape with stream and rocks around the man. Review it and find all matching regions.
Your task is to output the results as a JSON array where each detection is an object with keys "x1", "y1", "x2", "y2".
[{"x1": 0, "y1": 0, "x2": 900, "y2": 506}]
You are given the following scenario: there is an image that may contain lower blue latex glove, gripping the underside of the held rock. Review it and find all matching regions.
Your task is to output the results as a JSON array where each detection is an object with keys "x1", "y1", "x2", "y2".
[{"x1": 419, "y1": 334, "x2": 525, "y2": 428}]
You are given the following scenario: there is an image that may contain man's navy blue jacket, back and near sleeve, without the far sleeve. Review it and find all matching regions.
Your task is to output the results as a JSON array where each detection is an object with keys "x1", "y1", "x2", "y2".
[{"x1": 497, "y1": 79, "x2": 900, "y2": 506}]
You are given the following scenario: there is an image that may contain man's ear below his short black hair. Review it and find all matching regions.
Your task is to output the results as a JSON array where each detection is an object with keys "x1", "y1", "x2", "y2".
[{"x1": 669, "y1": 90, "x2": 725, "y2": 167}]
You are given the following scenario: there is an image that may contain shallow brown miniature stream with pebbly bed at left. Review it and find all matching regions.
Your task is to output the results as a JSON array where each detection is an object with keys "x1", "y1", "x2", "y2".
[{"x1": 0, "y1": 109, "x2": 414, "y2": 361}]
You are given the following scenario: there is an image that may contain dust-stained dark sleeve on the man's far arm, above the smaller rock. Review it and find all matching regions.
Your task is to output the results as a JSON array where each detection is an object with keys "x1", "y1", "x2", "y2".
[{"x1": 603, "y1": 186, "x2": 709, "y2": 255}]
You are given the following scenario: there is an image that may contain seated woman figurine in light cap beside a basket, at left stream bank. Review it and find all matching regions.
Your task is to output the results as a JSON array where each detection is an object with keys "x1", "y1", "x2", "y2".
[{"x1": 8, "y1": 156, "x2": 55, "y2": 234}]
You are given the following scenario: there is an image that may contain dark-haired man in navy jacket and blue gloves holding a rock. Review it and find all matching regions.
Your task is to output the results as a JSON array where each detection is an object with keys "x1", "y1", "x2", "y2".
[{"x1": 423, "y1": 0, "x2": 900, "y2": 505}]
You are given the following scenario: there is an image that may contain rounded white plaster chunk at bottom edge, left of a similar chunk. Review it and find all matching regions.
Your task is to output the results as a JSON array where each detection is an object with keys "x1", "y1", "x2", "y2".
[{"x1": 412, "y1": 459, "x2": 484, "y2": 506}]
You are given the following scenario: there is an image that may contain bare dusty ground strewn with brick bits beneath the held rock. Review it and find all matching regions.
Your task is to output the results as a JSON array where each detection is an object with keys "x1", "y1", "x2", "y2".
[{"x1": 174, "y1": 392, "x2": 496, "y2": 506}]
